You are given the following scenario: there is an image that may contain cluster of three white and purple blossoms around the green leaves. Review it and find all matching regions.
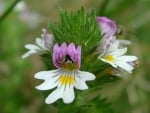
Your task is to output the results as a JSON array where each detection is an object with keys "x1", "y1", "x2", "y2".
[{"x1": 22, "y1": 17, "x2": 137, "y2": 104}]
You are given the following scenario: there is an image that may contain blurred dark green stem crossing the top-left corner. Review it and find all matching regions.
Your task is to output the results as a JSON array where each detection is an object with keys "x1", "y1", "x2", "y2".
[{"x1": 0, "y1": 0, "x2": 21, "y2": 22}]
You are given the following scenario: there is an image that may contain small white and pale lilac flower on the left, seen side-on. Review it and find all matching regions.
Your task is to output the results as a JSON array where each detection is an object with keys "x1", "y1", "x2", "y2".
[{"x1": 22, "y1": 29, "x2": 53, "y2": 58}]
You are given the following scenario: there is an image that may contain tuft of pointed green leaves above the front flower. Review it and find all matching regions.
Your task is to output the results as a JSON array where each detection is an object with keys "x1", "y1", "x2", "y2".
[{"x1": 50, "y1": 7, "x2": 101, "y2": 57}]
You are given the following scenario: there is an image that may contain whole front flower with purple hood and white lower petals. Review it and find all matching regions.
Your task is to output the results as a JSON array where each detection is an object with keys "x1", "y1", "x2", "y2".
[{"x1": 34, "y1": 43, "x2": 95, "y2": 104}]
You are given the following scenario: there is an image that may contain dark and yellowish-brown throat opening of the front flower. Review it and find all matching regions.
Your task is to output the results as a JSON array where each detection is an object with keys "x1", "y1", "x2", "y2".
[{"x1": 63, "y1": 55, "x2": 79, "y2": 71}]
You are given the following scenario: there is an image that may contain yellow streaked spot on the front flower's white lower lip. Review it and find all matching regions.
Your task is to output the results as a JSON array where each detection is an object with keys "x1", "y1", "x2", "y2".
[{"x1": 59, "y1": 75, "x2": 75, "y2": 85}]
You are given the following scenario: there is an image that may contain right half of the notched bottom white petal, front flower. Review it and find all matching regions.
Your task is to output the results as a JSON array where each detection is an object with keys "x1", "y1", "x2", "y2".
[{"x1": 62, "y1": 85, "x2": 75, "y2": 104}]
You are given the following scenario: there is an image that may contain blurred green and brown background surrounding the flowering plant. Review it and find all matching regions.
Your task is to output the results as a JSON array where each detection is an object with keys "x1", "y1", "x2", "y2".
[{"x1": 0, "y1": 0, "x2": 150, "y2": 113}]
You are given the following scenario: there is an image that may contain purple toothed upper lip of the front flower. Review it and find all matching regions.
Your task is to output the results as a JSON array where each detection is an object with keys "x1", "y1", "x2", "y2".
[{"x1": 53, "y1": 42, "x2": 81, "y2": 69}]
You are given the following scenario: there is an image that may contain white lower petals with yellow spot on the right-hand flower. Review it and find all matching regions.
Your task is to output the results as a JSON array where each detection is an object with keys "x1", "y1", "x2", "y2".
[{"x1": 99, "y1": 40, "x2": 137, "y2": 73}]
